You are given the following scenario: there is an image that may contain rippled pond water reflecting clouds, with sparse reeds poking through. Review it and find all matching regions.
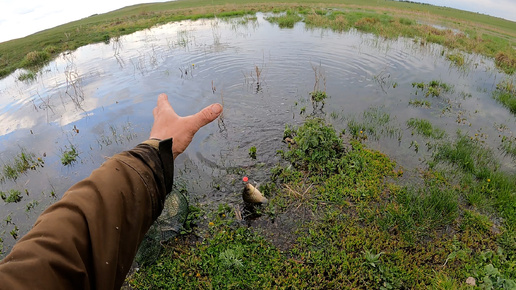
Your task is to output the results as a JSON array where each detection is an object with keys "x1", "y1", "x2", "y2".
[{"x1": 0, "y1": 14, "x2": 516, "y2": 252}]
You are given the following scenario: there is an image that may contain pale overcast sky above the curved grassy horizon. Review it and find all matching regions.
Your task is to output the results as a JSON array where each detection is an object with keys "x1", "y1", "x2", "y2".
[{"x1": 0, "y1": 0, "x2": 516, "y2": 42}]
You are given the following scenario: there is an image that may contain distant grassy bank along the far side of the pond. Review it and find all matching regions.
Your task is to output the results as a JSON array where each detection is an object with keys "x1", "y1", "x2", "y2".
[{"x1": 0, "y1": 0, "x2": 516, "y2": 77}]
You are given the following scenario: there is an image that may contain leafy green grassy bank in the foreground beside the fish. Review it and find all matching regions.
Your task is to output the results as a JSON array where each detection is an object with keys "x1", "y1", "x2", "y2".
[{"x1": 128, "y1": 114, "x2": 516, "y2": 289}]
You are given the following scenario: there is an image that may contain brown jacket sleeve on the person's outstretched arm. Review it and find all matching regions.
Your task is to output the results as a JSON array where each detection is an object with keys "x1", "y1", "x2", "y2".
[{"x1": 0, "y1": 141, "x2": 173, "y2": 289}]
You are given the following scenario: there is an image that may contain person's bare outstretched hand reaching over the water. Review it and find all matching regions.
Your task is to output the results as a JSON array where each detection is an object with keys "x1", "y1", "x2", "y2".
[{"x1": 150, "y1": 94, "x2": 222, "y2": 159}]
